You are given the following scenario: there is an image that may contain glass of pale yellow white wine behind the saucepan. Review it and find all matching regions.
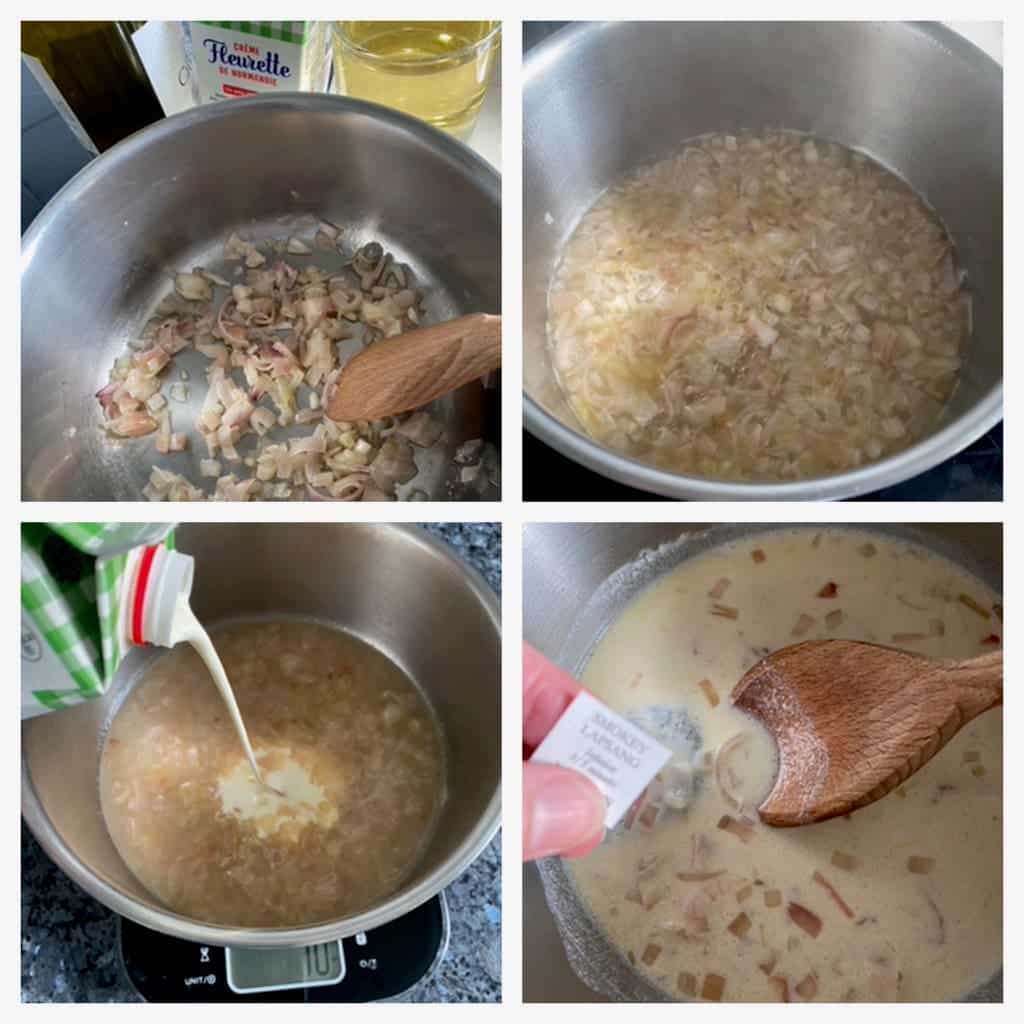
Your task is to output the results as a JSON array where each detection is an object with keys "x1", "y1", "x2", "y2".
[{"x1": 334, "y1": 22, "x2": 501, "y2": 138}]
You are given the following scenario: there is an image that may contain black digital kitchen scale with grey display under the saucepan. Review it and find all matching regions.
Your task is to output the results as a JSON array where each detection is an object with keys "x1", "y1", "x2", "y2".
[{"x1": 118, "y1": 893, "x2": 449, "y2": 1002}]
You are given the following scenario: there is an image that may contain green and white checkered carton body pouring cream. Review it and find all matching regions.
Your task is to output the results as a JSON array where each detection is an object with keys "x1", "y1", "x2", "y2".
[{"x1": 22, "y1": 522, "x2": 174, "y2": 719}]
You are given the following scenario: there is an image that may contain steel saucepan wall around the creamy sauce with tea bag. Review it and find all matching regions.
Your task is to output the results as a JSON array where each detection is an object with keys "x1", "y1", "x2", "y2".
[{"x1": 522, "y1": 523, "x2": 1002, "y2": 1002}]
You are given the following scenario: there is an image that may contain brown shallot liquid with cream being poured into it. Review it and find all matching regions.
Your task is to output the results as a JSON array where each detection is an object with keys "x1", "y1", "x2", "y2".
[{"x1": 100, "y1": 622, "x2": 443, "y2": 927}]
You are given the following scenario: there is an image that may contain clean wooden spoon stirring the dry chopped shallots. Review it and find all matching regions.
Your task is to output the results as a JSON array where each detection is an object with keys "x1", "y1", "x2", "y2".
[{"x1": 327, "y1": 313, "x2": 502, "y2": 422}]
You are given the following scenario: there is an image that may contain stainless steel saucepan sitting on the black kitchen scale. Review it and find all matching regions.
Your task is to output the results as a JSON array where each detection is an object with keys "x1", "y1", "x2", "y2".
[{"x1": 22, "y1": 523, "x2": 501, "y2": 948}]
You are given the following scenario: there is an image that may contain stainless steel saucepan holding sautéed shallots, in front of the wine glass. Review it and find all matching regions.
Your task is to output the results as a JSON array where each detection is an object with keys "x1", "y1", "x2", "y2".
[{"x1": 22, "y1": 93, "x2": 501, "y2": 501}]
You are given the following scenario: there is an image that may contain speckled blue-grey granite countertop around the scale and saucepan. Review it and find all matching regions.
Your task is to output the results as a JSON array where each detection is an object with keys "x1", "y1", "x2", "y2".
[{"x1": 22, "y1": 523, "x2": 502, "y2": 1002}]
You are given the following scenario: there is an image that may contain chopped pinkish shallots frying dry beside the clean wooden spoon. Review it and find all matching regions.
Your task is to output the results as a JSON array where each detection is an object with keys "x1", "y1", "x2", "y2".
[{"x1": 96, "y1": 227, "x2": 446, "y2": 501}]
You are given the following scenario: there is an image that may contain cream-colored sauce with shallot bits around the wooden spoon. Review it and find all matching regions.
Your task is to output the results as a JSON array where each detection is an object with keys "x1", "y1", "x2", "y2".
[{"x1": 568, "y1": 528, "x2": 1002, "y2": 1001}]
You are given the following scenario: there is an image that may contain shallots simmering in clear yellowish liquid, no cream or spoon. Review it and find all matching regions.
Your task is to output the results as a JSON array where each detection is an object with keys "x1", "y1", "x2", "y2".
[{"x1": 548, "y1": 132, "x2": 970, "y2": 480}]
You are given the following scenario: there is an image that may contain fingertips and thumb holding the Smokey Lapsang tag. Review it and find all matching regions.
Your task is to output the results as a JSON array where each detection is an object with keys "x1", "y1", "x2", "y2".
[{"x1": 522, "y1": 643, "x2": 607, "y2": 860}]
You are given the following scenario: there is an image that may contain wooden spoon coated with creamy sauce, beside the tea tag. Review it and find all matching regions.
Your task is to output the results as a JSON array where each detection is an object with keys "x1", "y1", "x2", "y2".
[{"x1": 732, "y1": 640, "x2": 1002, "y2": 827}]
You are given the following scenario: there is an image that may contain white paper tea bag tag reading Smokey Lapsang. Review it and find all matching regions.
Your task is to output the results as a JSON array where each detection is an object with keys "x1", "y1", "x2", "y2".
[{"x1": 530, "y1": 690, "x2": 672, "y2": 828}]
